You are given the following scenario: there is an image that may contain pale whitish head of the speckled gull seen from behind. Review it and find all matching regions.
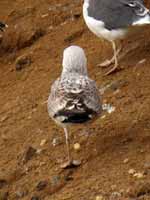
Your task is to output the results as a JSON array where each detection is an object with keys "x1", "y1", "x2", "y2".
[{"x1": 62, "y1": 46, "x2": 87, "y2": 75}]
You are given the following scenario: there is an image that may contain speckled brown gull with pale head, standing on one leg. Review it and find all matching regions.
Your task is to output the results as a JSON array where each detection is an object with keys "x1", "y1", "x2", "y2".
[{"x1": 48, "y1": 46, "x2": 102, "y2": 168}]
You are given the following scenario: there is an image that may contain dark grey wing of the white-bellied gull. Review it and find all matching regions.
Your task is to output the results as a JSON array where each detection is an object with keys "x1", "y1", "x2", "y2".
[{"x1": 88, "y1": 0, "x2": 149, "y2": 30}]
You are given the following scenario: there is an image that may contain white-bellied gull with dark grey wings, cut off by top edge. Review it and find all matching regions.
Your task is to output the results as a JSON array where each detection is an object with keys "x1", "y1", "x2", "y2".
[{"x1": 83, "y1": 0, "x2": 150, "y2": 74}]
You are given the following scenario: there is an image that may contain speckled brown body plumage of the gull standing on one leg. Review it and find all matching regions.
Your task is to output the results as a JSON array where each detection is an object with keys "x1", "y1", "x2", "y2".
[{"x1": 48, "y1": 74, "x2": 101, "y2": 123}]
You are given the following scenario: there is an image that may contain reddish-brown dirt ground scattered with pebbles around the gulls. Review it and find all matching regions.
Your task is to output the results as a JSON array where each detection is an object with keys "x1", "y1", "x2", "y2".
[{"x1": 0, "y1": 0, "x2": 150, "y2": 200}]
